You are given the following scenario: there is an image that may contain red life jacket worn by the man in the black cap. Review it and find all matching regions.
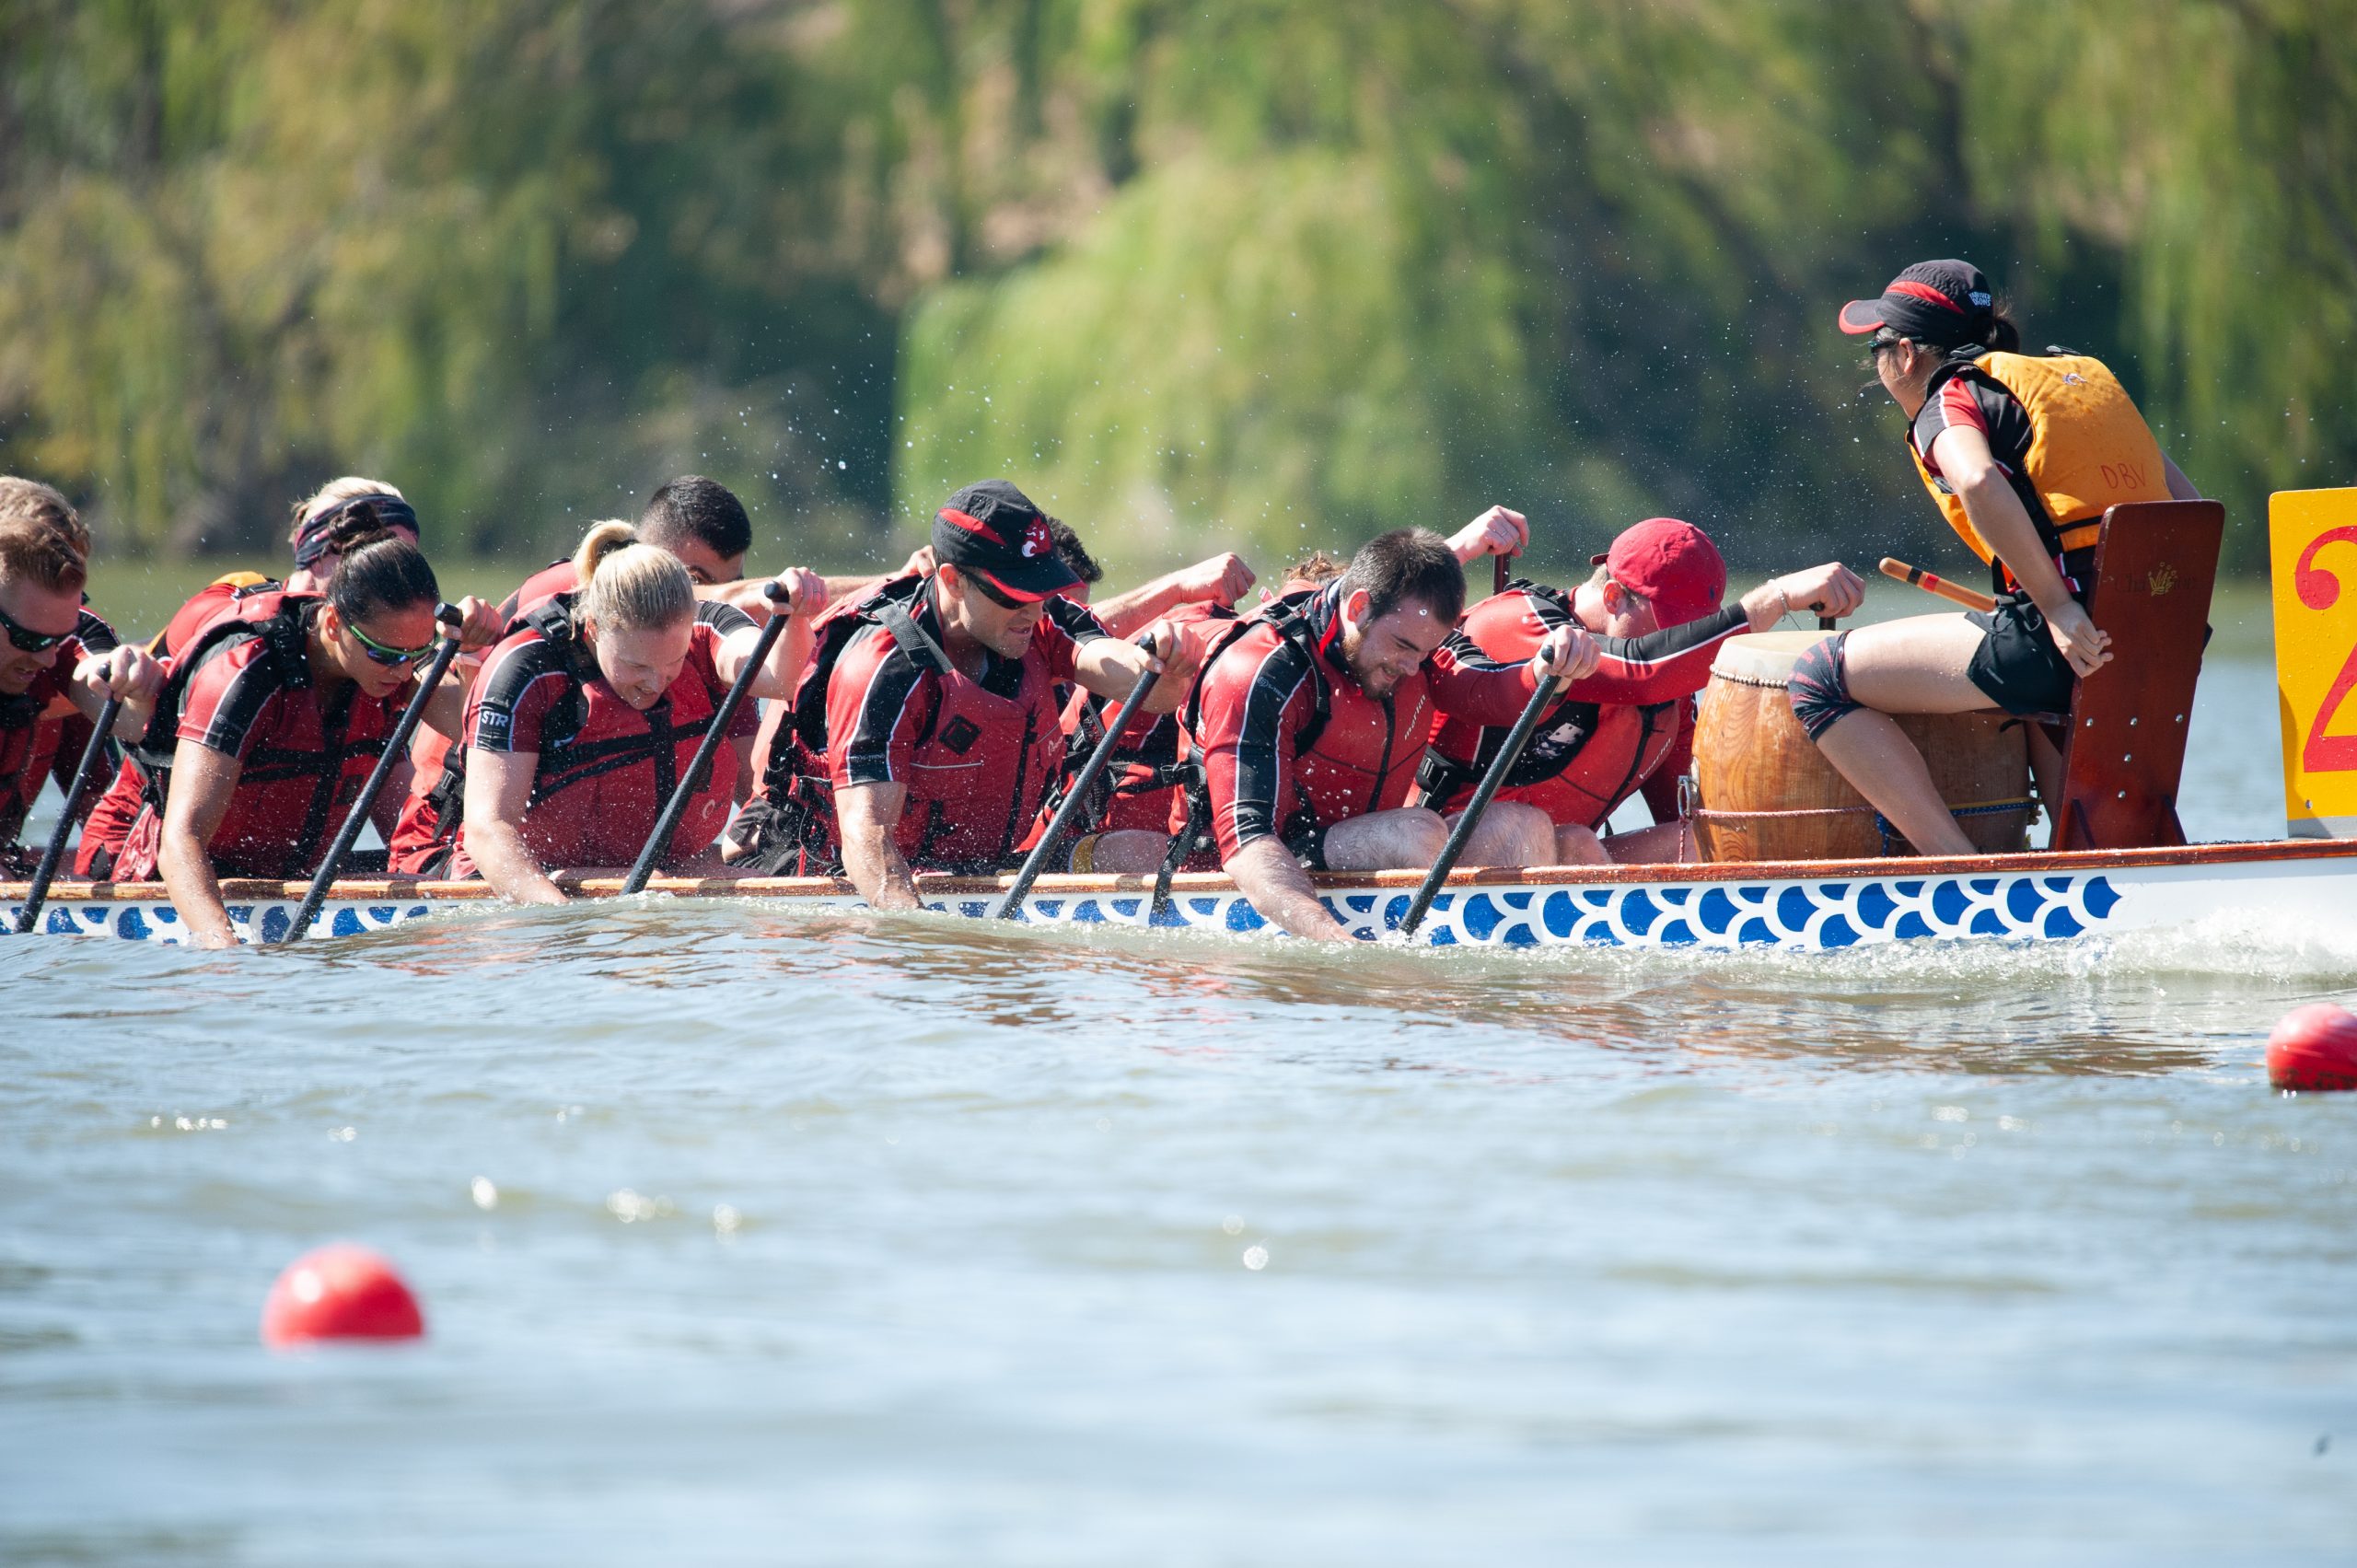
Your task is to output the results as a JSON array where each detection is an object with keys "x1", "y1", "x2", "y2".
[{"x1": 737, "y1": 577, "x2": 1065, "y2": 875}]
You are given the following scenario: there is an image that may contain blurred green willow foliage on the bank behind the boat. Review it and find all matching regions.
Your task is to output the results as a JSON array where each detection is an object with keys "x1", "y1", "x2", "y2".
[{"x1": 0, "y1": 0, "x2": 2357, "y2": 579}]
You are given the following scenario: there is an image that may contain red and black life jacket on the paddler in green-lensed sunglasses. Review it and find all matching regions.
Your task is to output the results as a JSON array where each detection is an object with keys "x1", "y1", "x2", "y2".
[{"x1": 75, "y1": 585, "x2": 394, "y2": 882}]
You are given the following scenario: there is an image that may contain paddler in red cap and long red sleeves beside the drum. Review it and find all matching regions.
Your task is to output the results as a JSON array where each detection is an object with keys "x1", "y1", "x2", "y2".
[{"x1": 1417, "y1": 517, "x2": 1864, "y2": 865}]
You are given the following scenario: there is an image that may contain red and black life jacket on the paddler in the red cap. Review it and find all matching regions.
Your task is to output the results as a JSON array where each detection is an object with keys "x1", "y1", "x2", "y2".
[{"x1": 1417, "y1": 577, "x2": 1685, "y2": 828}]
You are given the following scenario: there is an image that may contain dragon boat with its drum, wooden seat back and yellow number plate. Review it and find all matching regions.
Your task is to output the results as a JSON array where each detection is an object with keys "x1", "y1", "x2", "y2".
[{"x1": 18, "y1": 488, "x2": 2357, "y2": 953}]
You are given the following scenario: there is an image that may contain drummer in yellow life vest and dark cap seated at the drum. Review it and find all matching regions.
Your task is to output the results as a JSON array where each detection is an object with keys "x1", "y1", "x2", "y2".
[{"x1": 1792, "y1": 261, "x2": 2199, "y2": 856}]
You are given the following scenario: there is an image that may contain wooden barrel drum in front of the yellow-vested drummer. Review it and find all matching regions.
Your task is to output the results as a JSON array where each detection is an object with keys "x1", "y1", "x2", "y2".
[{"x1": 1692, "y1": 632, "x2": 2029, "y2": 861}]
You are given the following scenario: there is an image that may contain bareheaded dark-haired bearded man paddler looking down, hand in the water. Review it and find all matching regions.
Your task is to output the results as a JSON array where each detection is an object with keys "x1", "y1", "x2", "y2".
[{"x1": 1174, "y1": 528, "x2": 1596, "y2": 941}]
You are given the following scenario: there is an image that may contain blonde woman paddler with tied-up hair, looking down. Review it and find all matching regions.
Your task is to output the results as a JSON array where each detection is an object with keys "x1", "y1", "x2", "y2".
[{"x1": 449, "y1": 521, "x2": 828, "y2": 903}]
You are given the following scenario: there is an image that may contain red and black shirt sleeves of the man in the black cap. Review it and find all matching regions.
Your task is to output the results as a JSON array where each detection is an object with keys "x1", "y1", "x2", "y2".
[{"x1": 828, "y1": 592, "x2": 1106, "y2": 790}]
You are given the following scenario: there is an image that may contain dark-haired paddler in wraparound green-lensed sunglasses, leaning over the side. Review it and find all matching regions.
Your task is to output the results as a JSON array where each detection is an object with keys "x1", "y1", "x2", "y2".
[{"x1": 77, "y1": 538, "x2": 459, "y2": 947}]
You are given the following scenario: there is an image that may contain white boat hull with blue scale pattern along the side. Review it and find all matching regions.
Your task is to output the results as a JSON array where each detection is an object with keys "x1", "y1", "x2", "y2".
[{"x1": 0, "y1": 840, "x2": 2357, "y2": 950}]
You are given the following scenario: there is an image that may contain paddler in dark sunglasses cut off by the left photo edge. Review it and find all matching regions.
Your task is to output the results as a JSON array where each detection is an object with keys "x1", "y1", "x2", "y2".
[{"x1": 0, "y1": 476, "x2": 163, "y2": 875}]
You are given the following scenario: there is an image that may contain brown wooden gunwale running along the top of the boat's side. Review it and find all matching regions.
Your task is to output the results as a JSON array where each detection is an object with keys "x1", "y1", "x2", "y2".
[{"x1": 0, "y1": 840, "x2": 2357, "y2": 903}]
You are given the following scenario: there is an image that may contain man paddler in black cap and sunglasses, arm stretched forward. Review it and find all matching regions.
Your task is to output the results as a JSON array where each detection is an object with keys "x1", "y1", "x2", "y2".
[{"x1": 739, "y1": 479, "x2": 1197, "y2": 911}]
